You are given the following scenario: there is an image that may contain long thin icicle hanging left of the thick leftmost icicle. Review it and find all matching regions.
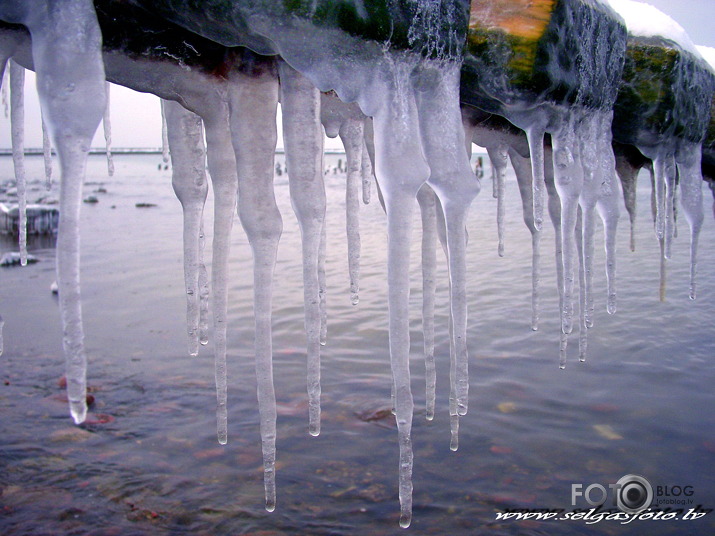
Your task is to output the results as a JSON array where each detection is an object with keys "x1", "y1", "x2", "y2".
[{"x1": 10, "y1": 60, "x2": 27, "y2": 266}]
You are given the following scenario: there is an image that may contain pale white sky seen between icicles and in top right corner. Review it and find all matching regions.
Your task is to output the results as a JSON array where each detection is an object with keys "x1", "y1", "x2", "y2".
[{"x1": 0, "y1": 0, "x2": 715, "y2": 148}]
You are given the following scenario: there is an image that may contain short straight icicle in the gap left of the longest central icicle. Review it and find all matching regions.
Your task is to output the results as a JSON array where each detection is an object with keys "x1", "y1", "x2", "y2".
[{"x1": 340, "y1": 118, "x2": 365, "y2": 305}]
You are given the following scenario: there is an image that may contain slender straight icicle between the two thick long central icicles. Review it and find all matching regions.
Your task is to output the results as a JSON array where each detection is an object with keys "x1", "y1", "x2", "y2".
[{"x1": 417, "y1": 184, "x2": 437, "y2": 421}]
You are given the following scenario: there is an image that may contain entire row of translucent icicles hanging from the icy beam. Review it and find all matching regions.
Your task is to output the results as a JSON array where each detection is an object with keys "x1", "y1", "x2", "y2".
[{"x1": 0, "y1": 0, "x2": 702, "y2": 527}]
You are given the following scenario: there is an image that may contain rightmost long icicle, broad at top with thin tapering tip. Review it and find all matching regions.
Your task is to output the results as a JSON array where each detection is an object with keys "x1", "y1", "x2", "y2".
[{"x1": 677, "y1": 142, "x2": 704, "y2": 300}]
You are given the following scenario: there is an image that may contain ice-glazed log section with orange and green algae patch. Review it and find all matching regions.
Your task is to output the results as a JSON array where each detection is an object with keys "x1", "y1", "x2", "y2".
[{"x1": 462, "y1": 0, "x2": 626, "y2": 115}]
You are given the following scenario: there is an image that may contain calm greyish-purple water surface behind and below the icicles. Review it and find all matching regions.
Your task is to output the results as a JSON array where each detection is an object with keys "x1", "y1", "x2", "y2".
[{"x1": 0, "y1": 155, "x2": 715, "y2": 536}]
